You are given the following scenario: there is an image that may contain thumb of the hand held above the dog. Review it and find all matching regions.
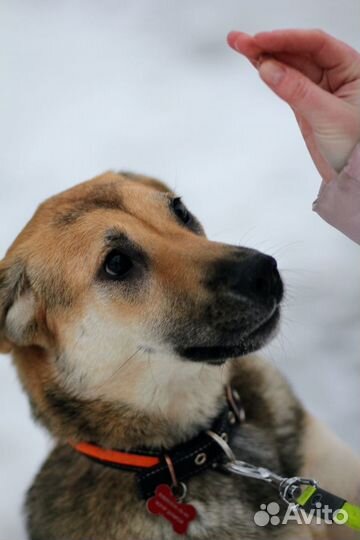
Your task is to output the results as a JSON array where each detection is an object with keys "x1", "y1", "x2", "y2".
[{"x1": 259, "y1": 60, "x2": 339, "y2": 126}]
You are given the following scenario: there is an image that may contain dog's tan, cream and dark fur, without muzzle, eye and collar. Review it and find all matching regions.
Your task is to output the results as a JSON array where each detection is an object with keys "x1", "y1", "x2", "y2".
[{"x1": 0, "y1": 173, "x2": 360, "y2": 540}]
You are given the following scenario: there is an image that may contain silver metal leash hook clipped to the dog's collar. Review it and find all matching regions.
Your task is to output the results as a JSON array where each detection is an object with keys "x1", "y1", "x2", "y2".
[{"x1": 207, "y1": 431, "x2": 317, "y2": 506}]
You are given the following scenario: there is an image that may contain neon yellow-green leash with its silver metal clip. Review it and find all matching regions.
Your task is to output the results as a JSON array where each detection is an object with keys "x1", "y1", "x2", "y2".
[{"x1": 208, "y1": 431, "x2": 360, "y2": 531}]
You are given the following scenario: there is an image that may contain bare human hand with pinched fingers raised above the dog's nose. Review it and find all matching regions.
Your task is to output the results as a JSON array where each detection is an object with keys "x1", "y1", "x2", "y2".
[{"x1": 228, "y1": 30, "x2": 360, "y2": 181}]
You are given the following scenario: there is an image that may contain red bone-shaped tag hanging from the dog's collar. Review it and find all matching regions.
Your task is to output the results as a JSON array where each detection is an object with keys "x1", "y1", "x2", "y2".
[{"x1": 146, "y1": 484, "x2": 196, "y2": 534}]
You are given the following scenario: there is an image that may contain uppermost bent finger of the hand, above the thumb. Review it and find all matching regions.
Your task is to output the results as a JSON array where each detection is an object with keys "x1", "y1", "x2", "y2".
[{"x1": 254, "y1": 29, "x2": 360, "y2": 69}]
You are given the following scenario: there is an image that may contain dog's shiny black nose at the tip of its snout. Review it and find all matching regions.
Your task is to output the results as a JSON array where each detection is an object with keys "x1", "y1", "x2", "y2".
[{"x1": 228, "y1": 253, "x2": 283, "y2": 302}]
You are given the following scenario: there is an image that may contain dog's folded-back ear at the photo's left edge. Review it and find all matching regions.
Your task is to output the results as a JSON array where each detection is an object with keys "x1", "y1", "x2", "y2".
[{"x1": 0, "y1": 260, "x2": 37, "y2": 353}]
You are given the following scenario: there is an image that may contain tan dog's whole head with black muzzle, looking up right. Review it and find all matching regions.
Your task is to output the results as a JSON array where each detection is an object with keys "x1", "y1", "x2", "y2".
[{"x1": 0, "y1": 173, "x2": 283, "y2": 438}]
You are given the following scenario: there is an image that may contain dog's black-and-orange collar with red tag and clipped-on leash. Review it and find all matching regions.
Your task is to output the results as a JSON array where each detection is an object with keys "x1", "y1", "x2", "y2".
[{"x1": 69, "y1": 386, "x2": 360, "y2": 534}]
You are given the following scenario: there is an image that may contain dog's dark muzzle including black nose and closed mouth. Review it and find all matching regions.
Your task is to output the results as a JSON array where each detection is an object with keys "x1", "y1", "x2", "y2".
[{"x1": 176, "y1": 248, "x2": 284, "y2": 364}]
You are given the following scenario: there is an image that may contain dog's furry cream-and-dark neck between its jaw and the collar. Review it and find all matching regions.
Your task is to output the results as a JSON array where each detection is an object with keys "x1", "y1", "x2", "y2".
[{"x1": 16, "y1": 348, "x2": 229, "y2": 450}]
